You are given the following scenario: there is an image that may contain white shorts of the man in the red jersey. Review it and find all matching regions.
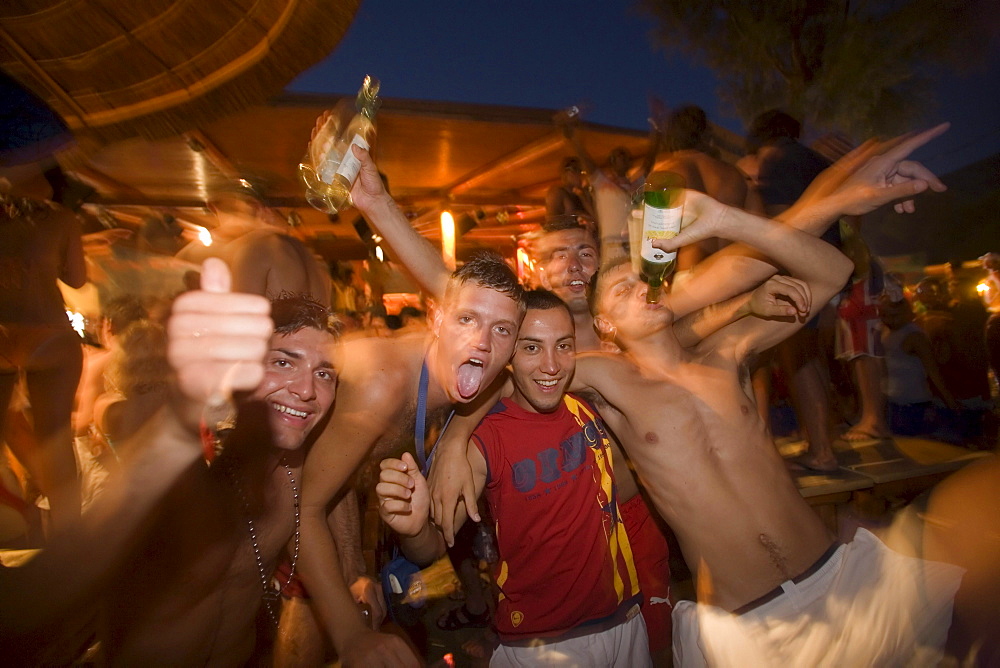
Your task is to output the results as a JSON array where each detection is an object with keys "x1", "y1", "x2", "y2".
[{"x1": 490, "y1": 615, "x2": 653, "y2": 668}]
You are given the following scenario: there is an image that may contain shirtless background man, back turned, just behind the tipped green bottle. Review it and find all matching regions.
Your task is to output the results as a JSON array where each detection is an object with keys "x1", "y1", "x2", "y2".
[{"x1": 659, "y1": 107, "x2": 762, "y2": 271}]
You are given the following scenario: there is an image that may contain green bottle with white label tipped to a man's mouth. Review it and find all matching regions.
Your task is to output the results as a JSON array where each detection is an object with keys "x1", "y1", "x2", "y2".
[{"x1": 639, "y1": 172, "x2": 684, "y2": 304}]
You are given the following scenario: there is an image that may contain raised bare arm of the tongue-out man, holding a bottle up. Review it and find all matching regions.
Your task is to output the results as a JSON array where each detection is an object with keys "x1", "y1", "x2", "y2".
[{"x1": 351, "y1": 146, "x2": 451, "y2": 300}]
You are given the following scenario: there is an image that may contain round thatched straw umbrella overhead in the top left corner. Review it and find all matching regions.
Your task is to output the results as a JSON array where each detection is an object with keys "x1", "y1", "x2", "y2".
[{"x1": 0, "y1": 0, "x2": 360, "y2": 144}]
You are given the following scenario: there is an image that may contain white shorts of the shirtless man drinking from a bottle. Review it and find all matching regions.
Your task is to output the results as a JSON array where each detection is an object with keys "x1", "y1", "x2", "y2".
[{"x1": 673, "y1": 529, "x2": 964, "y2": 668}]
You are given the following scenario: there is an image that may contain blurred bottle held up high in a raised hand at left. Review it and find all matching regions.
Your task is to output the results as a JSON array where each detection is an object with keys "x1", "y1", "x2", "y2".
[{"x1": 299, "y1": 75, "x2": 382, "y2": 214}]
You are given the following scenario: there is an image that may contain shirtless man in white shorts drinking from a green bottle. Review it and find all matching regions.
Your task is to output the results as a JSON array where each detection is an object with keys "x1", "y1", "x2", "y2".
[{"x1": 436, "y1": 128, "x2": 957, "y2": 665}]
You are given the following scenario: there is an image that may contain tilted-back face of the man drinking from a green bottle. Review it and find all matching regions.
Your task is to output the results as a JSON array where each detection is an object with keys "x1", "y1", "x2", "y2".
[{"x1": 596, "y1": 262, "x2": 673, "y2": 346}]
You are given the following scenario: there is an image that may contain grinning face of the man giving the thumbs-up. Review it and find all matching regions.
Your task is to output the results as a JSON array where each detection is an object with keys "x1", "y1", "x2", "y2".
[{"x1": 251, "y1": 327, "x2": 337, "y2": 450}]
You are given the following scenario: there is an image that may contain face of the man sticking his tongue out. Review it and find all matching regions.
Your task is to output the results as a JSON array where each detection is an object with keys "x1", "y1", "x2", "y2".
[{"x1": 432, "y1": 281, "x2": 521, "y2": 403}]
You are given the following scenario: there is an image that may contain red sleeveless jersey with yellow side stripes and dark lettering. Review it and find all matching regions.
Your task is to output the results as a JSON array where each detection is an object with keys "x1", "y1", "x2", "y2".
[{"x1": 473, "y1": 394, "x2": 641, "y2": 642}]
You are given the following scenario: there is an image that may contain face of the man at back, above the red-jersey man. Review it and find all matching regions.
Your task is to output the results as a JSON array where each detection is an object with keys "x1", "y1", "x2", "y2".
[{"x1": 538, "y1": 227, "x2": 599, "y2": 313}]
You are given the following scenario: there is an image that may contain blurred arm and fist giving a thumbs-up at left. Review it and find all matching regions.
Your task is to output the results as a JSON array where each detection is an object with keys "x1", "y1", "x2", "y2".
[{"x1": 0, "y1": 259, "x2": 274, "y2": 660}]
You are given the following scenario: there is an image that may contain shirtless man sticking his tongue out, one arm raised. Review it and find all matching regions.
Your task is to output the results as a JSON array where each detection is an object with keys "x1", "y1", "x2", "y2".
[{"x1": 301, "y1": 149, "x2": 524, "y2": 666}]
